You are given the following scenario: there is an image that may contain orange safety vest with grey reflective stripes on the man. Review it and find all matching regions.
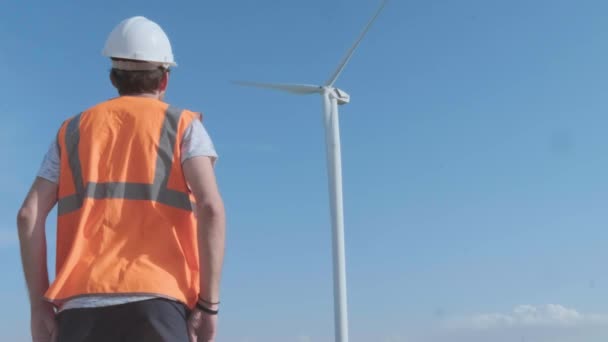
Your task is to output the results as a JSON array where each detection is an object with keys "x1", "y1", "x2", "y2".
[{"x1": 45, "y1": 96, "x2": 202, "y2": 307}]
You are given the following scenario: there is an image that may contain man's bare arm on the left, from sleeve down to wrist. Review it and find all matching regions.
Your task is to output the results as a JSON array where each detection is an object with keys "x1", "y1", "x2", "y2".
[{"x1": 17, "y1": 177, "x2": 57, "y2": 309}]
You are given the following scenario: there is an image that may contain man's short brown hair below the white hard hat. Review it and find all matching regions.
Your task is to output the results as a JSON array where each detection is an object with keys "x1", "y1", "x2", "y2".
[{"x1": 110, "y1": 59, "x2": 168, "y2": 95}]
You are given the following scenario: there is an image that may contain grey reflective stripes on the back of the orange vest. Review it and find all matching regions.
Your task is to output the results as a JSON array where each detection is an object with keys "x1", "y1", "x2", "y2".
[{"x1": 57, "y1": 106, "x2": 192, "y2": 215}]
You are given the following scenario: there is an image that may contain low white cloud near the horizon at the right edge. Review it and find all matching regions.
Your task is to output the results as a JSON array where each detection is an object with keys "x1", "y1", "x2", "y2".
[{"x1": 447, "y1": 304, "x2": 608, "y2": 330}]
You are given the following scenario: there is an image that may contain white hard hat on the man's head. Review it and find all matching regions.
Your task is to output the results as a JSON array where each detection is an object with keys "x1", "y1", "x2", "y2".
[{"x1": 102, "y1": 16, "x2": 177, "y2": 70}]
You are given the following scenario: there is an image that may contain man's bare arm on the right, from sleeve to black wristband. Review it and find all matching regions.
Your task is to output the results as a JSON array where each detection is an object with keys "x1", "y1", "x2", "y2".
[{"x1": 183, "y1": 156, "x2": 226, "y2": 302}]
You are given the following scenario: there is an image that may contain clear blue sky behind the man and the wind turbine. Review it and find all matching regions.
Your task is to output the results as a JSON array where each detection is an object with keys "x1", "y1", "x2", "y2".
[{"x1": 0, "y1": 0, "x2": 608, "y2": 342}]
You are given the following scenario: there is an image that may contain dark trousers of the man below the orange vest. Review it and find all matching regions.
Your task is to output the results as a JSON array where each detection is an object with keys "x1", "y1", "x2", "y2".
[{"x1": 57, "y1": 299, "x2": 189, "y2": 342}]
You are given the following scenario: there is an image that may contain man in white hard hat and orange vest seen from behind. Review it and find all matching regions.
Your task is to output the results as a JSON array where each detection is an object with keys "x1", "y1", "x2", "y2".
[{"x1": 17, "y1": 17, "x2": 225, "y2": 342}]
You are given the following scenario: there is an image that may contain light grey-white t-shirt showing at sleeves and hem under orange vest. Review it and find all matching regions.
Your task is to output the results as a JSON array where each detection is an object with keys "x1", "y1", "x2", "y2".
[{"x1": 38, "y1": 120, "x2": 218, "y2": 311}]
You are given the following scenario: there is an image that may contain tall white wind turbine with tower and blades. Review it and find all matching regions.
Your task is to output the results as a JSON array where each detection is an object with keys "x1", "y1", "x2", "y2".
[{"x1": 235, "y1": 0, "x2": 388, "y2": 342}]
